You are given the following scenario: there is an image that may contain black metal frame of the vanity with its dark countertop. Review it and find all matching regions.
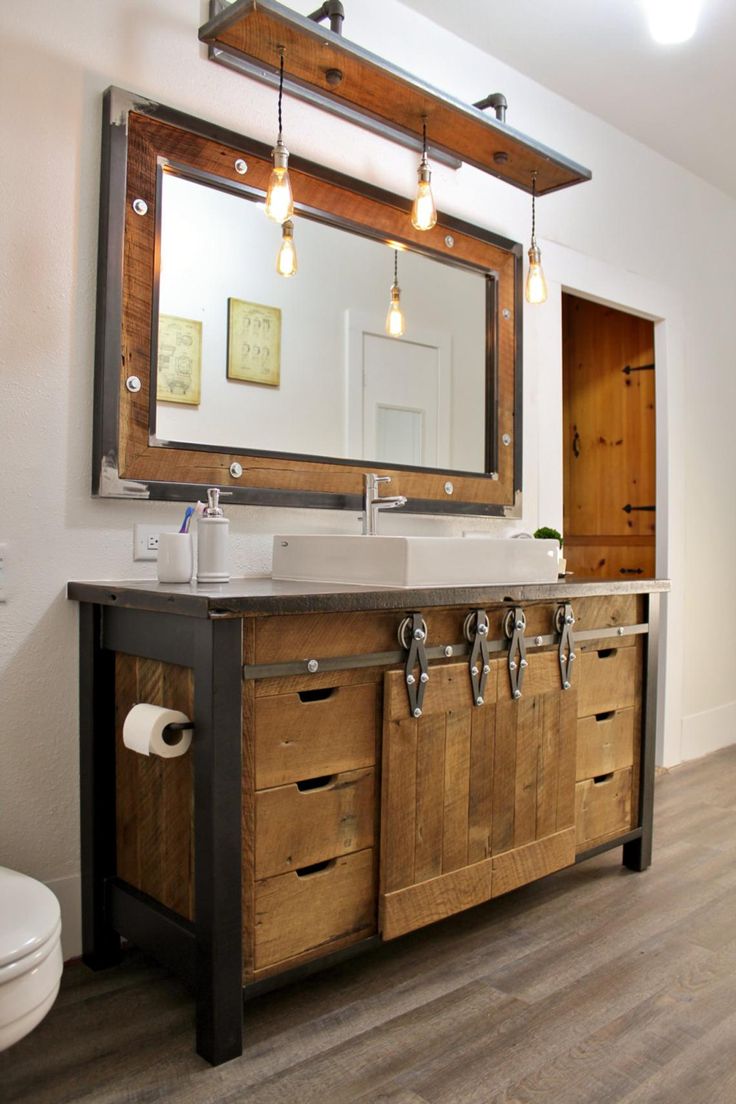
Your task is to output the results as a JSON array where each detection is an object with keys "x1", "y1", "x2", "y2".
[{"x1": 68, "y1": 580, "x2": 668, "y2": 1065}]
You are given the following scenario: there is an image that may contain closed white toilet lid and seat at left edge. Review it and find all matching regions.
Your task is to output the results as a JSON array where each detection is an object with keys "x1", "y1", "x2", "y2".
[{"x1": 0, "y1": 867, "x2": 61, "y2": 966}]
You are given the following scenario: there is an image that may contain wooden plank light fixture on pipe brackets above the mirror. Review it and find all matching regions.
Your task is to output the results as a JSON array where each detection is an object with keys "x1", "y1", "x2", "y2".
[{"x1": 200, "y1": 0, "x2": 591, "y2": 195}]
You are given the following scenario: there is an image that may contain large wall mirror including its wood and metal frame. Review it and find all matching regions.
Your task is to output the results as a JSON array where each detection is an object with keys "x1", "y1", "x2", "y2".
[{"x1": 94, "y1": 88, "x2": 521, "y2": 516}]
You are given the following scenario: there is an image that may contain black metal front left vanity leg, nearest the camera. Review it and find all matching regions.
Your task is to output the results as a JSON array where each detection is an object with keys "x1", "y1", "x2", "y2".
[{"x1": 192, "y1": 618, "x2": 243, "y2": 1065}]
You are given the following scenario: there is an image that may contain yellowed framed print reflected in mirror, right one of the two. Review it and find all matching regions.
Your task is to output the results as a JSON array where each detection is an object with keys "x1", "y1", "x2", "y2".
[{"x1": 227, "y1": 299, "x2": 281, "y2": 388}]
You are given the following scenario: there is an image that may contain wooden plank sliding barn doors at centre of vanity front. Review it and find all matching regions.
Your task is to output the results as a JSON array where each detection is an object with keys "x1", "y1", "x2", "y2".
[{"x1": 378, "y1": 652, "x2": 576, "y2": 940}]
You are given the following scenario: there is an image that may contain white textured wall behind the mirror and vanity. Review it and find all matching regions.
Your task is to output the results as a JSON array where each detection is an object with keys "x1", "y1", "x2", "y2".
[{"x1": 0, "y1": 0, "x2": 736, "y2": 954}]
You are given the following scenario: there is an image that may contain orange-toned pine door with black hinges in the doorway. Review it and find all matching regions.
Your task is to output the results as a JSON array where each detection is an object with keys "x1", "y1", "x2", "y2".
[{"x1": 563, "y1": 294, "x2": 657, "y2": 578}]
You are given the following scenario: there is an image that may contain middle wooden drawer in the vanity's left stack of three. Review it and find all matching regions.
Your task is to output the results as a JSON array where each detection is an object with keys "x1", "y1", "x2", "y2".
[{"x1": 255, "y1": 767, "x2": 375, "y2": 879}]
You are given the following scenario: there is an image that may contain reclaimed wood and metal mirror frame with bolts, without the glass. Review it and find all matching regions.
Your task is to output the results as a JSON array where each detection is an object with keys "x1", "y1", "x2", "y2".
[{"x1": 93, "y1": 88, "x2": 522, "y2": 517}]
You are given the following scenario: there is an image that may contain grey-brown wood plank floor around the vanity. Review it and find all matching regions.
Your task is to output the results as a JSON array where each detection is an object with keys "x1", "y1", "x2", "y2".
[{"x1": 0, "y1": 747, "x2": 736, "y2": 1104}]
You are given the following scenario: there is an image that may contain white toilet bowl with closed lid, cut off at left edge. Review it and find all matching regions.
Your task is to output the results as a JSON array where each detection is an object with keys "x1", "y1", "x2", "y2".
[{"x1": 0, "y1": 867, "x2": 64, "y2": 1050}]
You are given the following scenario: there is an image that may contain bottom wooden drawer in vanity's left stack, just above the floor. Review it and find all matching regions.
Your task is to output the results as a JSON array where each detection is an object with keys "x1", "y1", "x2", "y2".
[{"x1": 255, "y1": 848, "x2": 375, "y2": 974}]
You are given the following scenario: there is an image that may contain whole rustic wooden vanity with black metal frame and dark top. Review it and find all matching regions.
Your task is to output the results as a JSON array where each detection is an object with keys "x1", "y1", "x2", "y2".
[{"x1": 68, "y1": 578, "x2": 668, "y2": 1063}]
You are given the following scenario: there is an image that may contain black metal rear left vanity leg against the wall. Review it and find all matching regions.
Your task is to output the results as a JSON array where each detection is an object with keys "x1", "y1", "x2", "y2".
[{"x1": 79, "y1": 602, "x2": 120, "y2": 969}]
